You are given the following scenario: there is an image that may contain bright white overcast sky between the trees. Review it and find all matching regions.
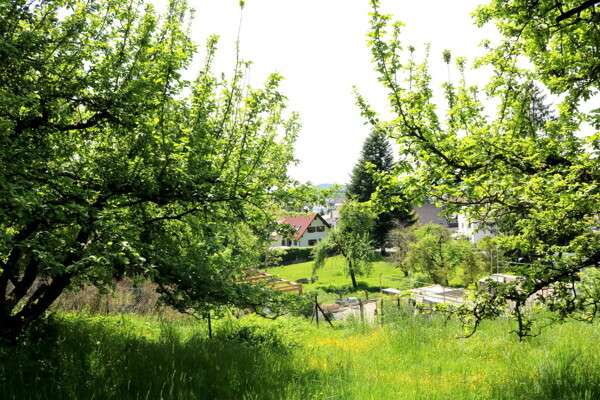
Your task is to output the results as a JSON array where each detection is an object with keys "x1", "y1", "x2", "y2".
[{"x1": 172, "y1": 0, "x2": 490, "y2": 184}]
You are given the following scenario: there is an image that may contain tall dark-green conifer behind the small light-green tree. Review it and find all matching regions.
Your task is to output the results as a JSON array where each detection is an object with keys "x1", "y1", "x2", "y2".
[{"x1": 346, "y1": 130, "x2": 415, "y2": 254}]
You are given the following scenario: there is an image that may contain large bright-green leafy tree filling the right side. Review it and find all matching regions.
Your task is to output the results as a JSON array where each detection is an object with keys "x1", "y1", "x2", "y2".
[{"x1": 359, "y1": 0, "x2": 600, "y2": 338}]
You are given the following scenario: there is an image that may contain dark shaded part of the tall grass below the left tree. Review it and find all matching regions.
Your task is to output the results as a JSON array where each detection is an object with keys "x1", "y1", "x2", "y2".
[{"x1": 0, "y1": 315, "x2": 314, "y2": 400}]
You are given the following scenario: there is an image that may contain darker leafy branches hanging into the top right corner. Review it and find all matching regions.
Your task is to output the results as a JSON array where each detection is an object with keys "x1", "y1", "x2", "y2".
[{"x1": 475, "y1": 0, "x2": 600, "y2": 108}]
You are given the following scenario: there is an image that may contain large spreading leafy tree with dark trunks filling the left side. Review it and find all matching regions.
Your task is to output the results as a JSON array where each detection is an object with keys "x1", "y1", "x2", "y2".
[{"x1": 0, "y1": 0, "x2": 310, "y2": 342}]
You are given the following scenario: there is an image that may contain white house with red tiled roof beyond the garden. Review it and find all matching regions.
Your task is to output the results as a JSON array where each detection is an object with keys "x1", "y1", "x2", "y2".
[{"x1": 273, "y1": 213, "x2": 331, "y2": 247}]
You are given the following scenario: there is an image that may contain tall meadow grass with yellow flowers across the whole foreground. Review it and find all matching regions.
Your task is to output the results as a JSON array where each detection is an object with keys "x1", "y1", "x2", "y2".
[{"x1": 0, "y1": 304, "x2": 600, "y2": 400}]
